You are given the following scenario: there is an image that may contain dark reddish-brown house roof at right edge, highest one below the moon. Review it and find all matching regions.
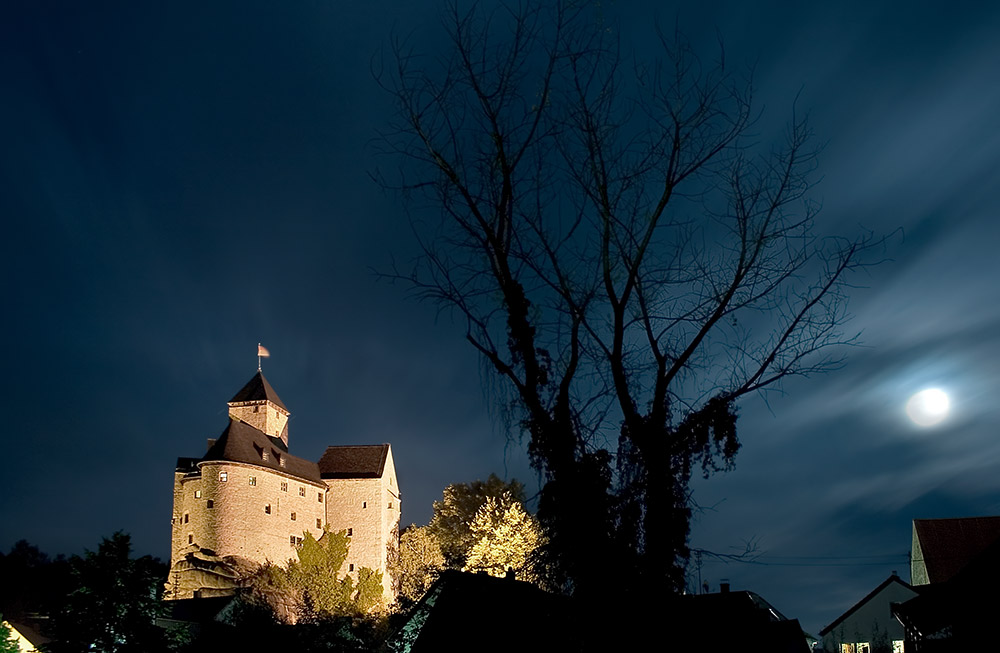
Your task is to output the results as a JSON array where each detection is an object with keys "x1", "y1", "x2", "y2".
[{"x1": 913, "y1": 517, "x2": 1000, "y2": 583}]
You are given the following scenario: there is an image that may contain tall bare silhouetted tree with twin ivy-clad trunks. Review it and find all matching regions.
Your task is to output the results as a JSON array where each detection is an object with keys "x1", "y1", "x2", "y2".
[{"x1": 377, "y1": 3, "x2": 874, "y2": 595}]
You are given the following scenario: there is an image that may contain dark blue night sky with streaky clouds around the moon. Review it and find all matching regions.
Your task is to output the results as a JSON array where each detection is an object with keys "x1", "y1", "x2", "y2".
[{"x1": 0, "y1": 0, "x2": 1000, "y2": 634}]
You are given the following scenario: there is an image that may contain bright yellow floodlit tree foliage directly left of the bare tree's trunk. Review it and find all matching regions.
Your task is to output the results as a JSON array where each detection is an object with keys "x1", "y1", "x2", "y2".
[{"x1": 465, "y1": 493, "x2": 545, "y2": 582}]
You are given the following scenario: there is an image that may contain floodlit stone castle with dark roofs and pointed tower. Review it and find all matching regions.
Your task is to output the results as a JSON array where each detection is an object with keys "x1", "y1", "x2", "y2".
[{"x1": 165, "y1": 369, "x2": 401, "y2": 604}]
